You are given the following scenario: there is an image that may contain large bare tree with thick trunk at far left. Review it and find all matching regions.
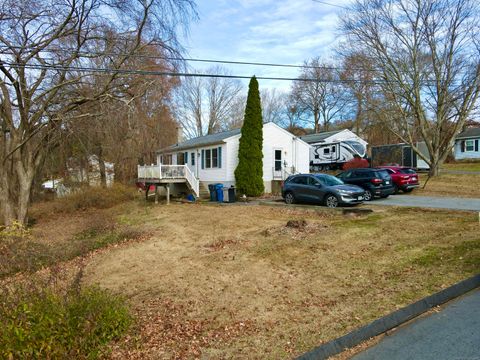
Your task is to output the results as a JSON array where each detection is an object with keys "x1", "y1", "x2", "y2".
[{"x1": 0, "y1": 0, "x2": 194, "y2": 224}]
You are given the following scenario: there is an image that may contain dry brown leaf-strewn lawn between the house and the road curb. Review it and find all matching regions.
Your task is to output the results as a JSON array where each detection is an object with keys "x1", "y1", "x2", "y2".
[{"x1": 74, "y1": 203, "x2": 480, "y2": 359}]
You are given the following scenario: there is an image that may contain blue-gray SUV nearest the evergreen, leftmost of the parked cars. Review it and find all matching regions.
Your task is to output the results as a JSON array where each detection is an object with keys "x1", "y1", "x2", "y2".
[{"x1": 282, "y1": 174, "x2": 365, "y2": 208}]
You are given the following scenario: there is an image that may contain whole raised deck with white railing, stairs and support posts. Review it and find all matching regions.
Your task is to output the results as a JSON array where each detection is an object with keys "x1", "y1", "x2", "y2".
[{"x1": 137, "y1": 164, "x2": 200, "y2": 202}]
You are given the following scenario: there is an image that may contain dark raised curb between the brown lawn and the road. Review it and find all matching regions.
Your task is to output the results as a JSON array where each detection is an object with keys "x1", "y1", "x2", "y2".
[{"x1": 297, "y1": 274, "x2": 480, "y2": 360}]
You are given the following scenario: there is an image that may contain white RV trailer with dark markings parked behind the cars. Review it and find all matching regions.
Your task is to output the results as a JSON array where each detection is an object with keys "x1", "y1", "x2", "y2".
[{"x1": 301, "y1": 130, "x2": 367, "y2": 172}]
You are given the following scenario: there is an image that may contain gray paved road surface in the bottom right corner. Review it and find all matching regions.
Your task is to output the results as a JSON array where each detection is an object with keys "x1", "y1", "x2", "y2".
[{"x1": 353, "y1": 290, "x2": 480, "y2": 360}]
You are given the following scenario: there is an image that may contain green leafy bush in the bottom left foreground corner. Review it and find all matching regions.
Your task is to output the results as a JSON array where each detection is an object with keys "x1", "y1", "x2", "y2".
[{"x1": 0, "y1": 286, "x2": 132, "y2": 359}]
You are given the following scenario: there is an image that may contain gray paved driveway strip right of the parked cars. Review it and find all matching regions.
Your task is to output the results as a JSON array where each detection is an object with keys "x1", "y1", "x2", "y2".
[{"x1": 371, "y1": 194, "x2": 480, "y2": 211}]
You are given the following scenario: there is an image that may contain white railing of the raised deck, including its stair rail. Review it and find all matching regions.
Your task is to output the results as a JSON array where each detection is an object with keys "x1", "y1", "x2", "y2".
[{"x1": 138, "y1": 164, "x2": 200, "y2": 196}]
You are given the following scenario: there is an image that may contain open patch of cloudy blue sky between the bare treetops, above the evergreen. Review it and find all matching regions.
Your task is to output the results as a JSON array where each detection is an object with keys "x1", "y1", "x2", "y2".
[{"x1": 180, "y1": 0, "x2": 351, "y2": 90}]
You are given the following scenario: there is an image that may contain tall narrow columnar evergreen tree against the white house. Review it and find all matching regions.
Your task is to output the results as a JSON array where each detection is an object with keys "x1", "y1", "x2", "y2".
[{"x1": 235, "y1": 76, "x2": 265, "y2": 196}]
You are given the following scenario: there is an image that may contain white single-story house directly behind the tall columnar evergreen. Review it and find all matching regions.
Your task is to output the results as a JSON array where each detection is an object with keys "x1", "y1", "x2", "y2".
[{"x1": 157, "y1": 122, "x2": 310, "y2": 193}]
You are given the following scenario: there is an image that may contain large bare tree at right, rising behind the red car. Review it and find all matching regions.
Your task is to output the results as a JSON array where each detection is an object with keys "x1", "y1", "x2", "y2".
[{"x1": 343, "y1": 0, "x2": 480, "y2": 175}]
